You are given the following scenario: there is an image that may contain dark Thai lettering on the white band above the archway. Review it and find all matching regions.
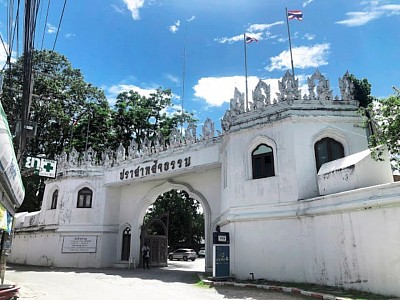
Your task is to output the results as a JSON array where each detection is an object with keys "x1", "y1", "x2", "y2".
[{"x1": 119, "y1": 156, "x2": 191, "y2": 180}]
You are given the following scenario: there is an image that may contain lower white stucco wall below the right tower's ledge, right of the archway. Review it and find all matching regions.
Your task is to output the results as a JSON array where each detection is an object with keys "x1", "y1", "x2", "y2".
[{"x1": 224, "y1": 183, "x2": 400, "y2": 296}]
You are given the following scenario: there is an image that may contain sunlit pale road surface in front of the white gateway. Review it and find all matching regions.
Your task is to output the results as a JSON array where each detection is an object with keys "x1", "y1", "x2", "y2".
[{"x1": 5, "y1": 262, "x2": 312, "y2": 300}]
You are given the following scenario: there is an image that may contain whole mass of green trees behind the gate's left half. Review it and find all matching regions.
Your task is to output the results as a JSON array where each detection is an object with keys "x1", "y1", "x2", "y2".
[{"x1": 1, "y1": 50, "x2": 196, "y2": 211}]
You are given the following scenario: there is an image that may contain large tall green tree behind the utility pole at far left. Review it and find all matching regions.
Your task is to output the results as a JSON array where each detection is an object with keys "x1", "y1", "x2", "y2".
[{"x1": 1, "y1": 50, "x2": 112, "y2": 211}]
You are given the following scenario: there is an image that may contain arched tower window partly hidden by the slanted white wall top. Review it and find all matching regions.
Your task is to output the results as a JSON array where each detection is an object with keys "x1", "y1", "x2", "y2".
[{"x1": 314, "y1": 138, "x2": 344, "y2": 171}]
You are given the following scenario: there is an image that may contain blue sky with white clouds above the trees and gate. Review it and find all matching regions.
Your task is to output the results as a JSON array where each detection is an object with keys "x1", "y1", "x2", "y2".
[{"x1": 0, "y1": 0, "x2": 400, "y2": 124}]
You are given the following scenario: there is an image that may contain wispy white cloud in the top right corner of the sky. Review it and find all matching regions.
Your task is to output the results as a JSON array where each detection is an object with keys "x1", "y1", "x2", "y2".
[{"x1": 336, "y1": 1, "x2": 400, "y2": 27}]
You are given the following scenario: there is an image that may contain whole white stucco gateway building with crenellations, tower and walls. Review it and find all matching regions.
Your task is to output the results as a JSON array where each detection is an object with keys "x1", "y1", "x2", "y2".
[{"x1": 9, "y1": 70, "x2": 400, "y2": 296}]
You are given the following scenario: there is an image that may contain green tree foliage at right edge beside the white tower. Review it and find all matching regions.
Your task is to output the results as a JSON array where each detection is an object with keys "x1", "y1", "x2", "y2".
[{"x1": 367, "y1": 88, "x2": 400, "y2": 170}]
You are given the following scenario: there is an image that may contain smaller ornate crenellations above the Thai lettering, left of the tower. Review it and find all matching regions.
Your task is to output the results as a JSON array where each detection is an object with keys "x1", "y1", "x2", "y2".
[{"x1": 56, "y1": 118, "x2": 221, "y2": 170}]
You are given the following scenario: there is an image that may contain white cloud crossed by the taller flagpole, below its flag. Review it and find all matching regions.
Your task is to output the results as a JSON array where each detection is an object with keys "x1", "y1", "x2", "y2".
[{"x1": 266, "y1": 43, "x2": 330, "y2": 71}]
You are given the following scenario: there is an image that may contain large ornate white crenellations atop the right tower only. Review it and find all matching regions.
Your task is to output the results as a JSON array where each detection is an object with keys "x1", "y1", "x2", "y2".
[{"x1": 221, "y1": 69, "x2": 354, "y2": 132}]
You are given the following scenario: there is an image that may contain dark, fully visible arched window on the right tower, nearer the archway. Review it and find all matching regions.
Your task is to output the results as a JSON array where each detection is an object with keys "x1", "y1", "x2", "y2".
[{"x1": 251, "y1": 144, "x2": 275, "y2": 179}]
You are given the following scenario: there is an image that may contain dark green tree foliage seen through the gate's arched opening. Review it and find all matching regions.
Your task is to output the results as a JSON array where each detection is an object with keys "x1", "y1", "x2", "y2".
[{"x1": 144, "y1": 190, "x2": 204, "y2": 248}]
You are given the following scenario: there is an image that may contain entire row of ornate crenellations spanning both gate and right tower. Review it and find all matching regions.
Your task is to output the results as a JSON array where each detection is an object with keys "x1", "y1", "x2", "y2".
[{"x1": 57, "y1": 69, "x2": 354, "y2": 169}]
